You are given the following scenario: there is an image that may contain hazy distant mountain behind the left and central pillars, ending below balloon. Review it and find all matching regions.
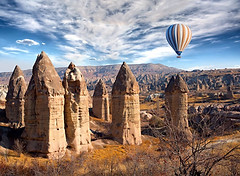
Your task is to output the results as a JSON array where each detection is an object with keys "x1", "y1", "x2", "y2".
[{"x1": 0, "y1": 64, "x2": 181, "y2": 93}]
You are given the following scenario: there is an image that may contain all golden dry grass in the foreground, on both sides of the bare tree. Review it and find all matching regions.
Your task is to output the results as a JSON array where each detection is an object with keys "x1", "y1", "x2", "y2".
[{"x1": 0, "y1": 132, "x2": 240, "y2": 176}]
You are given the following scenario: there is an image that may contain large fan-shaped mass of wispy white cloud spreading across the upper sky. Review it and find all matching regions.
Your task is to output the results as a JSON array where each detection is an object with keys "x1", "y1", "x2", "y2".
[{"x1": 0, "y1": 0, "x2": 240, "y2": 63}]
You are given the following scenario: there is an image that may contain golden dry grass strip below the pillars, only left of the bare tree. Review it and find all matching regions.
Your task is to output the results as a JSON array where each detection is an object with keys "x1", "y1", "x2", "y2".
[{"x1": 0, "y1": 137, "x2": 162, "y2": 176}]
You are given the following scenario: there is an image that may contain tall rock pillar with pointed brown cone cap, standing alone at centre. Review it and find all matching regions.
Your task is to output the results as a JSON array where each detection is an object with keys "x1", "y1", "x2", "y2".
[{"x1": 111, "y1": 62, "x2": 142, "y2": 145}]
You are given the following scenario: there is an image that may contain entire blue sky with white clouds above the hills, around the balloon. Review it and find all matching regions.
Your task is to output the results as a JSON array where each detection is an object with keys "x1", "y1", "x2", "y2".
[{"x1": 0, "y1": 0, "x2": 240, "y2": 72}]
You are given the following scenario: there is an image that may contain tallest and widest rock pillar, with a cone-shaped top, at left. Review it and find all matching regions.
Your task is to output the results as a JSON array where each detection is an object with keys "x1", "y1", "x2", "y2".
[{"x1": 22, "y1": 51, "x2": 67, "y2": 158}]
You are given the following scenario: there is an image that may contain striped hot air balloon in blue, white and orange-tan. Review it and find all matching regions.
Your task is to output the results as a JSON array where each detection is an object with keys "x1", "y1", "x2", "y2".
[{"x1": 166, "y1": 24, "x2": 192, "y2": 58}]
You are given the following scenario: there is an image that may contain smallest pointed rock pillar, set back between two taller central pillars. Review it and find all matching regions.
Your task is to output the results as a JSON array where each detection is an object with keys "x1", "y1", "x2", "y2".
[{"x1": 92, "y1": 79, "x2": 110, "y2": 121}]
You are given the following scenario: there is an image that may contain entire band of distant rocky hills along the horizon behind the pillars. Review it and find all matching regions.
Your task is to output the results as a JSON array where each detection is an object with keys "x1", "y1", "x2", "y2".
[{"x1": 0, "y1": 64, "x2": 240, "y2": 94}]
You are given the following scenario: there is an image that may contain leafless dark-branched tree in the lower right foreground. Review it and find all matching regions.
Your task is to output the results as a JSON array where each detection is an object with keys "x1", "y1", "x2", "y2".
[{"x1": 157, "y1": 106, "x2": 240, "y2": 176}]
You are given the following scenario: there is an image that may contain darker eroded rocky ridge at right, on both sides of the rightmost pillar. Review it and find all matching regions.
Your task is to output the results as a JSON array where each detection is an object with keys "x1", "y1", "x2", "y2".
[{"x1": 137, "y1": 69, "x2": 240, "y2": 92}]
